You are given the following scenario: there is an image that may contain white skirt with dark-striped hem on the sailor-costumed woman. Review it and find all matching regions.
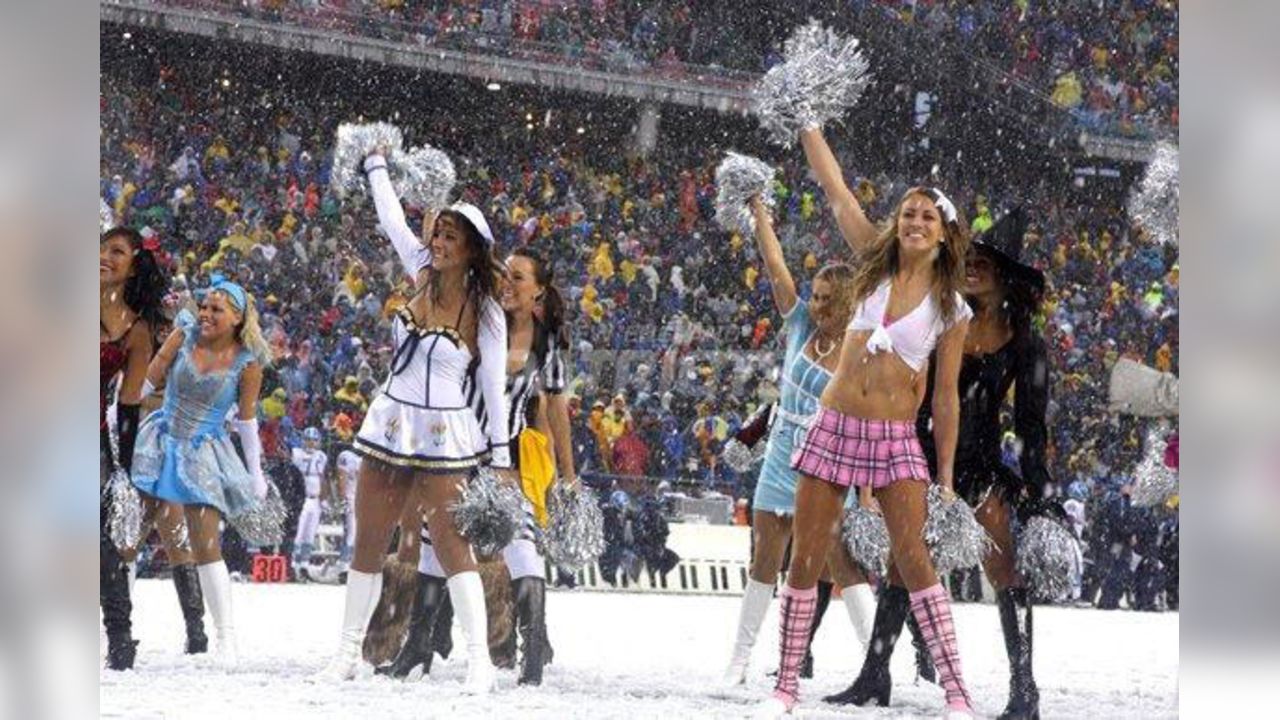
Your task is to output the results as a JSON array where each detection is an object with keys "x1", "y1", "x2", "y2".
[{"x1": 352, "y1": 393, "x2": 489, "y2": 474}]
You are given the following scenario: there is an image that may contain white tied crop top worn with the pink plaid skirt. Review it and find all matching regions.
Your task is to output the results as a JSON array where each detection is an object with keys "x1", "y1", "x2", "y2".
[{"x1": 849, "y1": 279, "x2": 973, "y2": 373}]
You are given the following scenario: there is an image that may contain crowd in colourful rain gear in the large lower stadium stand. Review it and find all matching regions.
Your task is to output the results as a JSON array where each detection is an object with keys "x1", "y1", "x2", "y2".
[{"x1": 100, "y1": 23, "x2": 1179, "y2": 604}]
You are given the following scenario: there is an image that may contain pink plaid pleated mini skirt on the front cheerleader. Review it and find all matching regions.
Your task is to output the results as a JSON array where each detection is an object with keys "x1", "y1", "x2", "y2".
[{"x1": 791, "y1": 407, "x2": 929, "y2": 488}]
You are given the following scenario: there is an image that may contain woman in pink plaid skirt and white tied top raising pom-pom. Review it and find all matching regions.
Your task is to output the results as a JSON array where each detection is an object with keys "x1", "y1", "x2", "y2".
[{"x1": 759, "y1": 128, "x2": 973, "y2": 717}]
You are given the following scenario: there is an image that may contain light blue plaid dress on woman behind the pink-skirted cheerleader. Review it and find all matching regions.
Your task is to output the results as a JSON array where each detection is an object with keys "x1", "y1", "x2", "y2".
[{"x1": 753, "y1": 299, "x2": 852, "y2": 515}]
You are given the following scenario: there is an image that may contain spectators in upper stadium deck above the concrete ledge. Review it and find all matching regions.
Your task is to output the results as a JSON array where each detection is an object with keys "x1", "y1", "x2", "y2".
[{"x1": 145, "y1": 0, "x2": 1179, "y2": 135}]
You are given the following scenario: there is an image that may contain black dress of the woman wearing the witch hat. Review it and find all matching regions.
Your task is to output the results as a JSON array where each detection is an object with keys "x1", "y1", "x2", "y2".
[{"x1": 915, "y1": 336, "x2": 1053, "y2": 505}]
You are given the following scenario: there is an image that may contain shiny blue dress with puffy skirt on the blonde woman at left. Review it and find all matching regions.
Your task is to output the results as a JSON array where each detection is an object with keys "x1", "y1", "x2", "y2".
[{"x1": 133, "y1": 319, "x2": 260, "y2": 523}]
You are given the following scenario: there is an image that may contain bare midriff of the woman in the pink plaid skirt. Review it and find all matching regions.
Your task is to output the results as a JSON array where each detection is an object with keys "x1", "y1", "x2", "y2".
[{"x1": 819, "y1": 331, "x2": 929, "y2": 423}]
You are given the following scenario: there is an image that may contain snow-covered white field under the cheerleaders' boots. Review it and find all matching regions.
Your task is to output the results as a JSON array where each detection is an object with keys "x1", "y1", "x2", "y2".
[{"x1": 100, "y1": 580, "x2": 1178, "y2": 720}]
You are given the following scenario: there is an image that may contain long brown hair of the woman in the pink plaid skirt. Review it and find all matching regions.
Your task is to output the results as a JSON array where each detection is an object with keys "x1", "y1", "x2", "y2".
[{"x1": 854, "y1": 187, "x2": 969, "y2": 323}]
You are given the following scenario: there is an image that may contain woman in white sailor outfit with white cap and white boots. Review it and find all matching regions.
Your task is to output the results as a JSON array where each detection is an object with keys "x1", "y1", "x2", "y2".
[{"x1": 319, "y1": 154, "x2": 511, "y2": 693}]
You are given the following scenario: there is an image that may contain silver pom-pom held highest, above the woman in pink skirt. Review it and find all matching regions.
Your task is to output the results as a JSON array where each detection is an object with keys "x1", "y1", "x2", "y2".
[{"x1": 751, "y1": 20, "x2": 870, "y2": 147}]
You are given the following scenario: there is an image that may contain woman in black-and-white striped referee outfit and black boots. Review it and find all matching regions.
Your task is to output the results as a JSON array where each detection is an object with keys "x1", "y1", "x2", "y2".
[{"x1": 379, "y1": 242, "x2": 577, "y2": 685}]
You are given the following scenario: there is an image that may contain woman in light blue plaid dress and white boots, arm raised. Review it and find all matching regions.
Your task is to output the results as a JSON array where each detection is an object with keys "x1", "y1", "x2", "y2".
[{"x1": 722, "y1": 199, "x2": 876, "y2": 687}]
